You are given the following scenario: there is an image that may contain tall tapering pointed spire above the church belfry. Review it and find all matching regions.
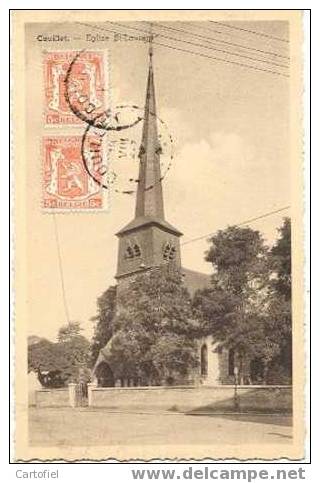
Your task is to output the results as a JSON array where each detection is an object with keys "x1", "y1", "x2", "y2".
[{"x1": 135, "y1": 40, "x2": 164, "y2": 220}]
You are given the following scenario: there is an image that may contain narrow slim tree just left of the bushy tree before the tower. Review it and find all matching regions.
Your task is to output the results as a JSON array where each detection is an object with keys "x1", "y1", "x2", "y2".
[{"x1": 90, "y1": 286, "x2": 117, "y2": 367}]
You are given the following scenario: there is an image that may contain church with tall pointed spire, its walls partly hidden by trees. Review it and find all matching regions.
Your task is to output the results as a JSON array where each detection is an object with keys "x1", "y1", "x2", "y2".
[{"x1": 93, "y1": 47, "x2": 235, "y2": 386}]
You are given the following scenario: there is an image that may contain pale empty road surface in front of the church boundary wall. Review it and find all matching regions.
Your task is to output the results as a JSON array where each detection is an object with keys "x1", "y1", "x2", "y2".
[{"x1": 29, "y1": 407, "x2": 292, "y2": 447}]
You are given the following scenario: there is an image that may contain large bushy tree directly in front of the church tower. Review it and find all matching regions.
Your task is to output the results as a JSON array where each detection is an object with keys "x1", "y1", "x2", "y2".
[{"x1": 107, "y1": 266, "x2": 199, "y2": 384}]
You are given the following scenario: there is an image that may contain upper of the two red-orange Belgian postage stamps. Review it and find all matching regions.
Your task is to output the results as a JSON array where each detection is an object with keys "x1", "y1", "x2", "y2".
[{"x1": 43, "y1": 51, "x2": 106, "y2": 126}]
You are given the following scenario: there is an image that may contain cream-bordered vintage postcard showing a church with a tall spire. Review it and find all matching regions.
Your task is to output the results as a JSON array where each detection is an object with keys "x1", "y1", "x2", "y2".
[{"x1": 11, "y1": 10, "x2": 306, "y2": 462}]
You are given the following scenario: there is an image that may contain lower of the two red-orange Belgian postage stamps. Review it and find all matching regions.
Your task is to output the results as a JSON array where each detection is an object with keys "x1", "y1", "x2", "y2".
[{"x1": 42, "y1": 136, "x2": 103, "y2": 210}]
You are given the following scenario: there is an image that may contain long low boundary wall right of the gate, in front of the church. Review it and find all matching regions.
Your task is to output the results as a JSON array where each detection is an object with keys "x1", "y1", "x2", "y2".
[{"x1": 89, "y1": 385, "x2": 292, "y2": 413}]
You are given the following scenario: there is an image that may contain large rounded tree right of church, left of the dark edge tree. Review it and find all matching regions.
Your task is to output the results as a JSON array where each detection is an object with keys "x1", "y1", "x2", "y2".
[{"x1": 193, "y1": 226, "x2": 272, "y2": 382}]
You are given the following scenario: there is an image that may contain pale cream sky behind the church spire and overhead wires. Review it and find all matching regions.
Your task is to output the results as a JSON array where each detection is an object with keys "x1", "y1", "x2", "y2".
[{"x1": 26, "y1": 21, "x2": 291, "y2": 340}]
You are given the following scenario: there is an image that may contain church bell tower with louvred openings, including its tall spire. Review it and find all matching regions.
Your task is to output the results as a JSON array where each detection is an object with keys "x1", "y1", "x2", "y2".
[{"x1": 116, "y1": 42, "x2": 182, "y2": 289}]
